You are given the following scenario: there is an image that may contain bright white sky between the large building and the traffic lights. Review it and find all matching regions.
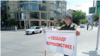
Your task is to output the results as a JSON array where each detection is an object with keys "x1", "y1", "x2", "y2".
[{"x1": 66, "y1": 0, "x2": 93, "y2": 15}]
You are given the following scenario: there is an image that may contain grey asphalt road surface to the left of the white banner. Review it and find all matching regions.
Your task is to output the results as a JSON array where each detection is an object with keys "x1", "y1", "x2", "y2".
[{"x1": 0, "y1": 31, "x2": 55, "y2": 56}]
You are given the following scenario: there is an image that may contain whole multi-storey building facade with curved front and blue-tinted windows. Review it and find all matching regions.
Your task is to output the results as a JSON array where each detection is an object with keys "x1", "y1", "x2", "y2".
[{"x1": 0, "y1": 0, "x2": 66, "y2": 28}]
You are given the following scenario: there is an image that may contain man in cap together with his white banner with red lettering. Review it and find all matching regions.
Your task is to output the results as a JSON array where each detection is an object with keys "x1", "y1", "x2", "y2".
[{"x1": 44, "y1": 15, "x2": 80, "y2": 56}]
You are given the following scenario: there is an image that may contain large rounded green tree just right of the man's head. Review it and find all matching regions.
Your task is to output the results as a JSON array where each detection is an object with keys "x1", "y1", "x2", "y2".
[{"x1": 72, "y1": 11, "x2": 86, "y2": 24}]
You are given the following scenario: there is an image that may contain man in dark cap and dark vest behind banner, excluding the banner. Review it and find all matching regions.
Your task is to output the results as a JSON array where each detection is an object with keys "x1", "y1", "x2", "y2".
[{"x1": 59, "y1": 15, "x2": 80, "y2": 56}]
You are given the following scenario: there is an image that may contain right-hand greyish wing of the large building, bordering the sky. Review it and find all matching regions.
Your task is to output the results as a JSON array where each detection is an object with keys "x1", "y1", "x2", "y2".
[{"x1": 50, "y1": 0, "x2": 67, "y2": 25}]
